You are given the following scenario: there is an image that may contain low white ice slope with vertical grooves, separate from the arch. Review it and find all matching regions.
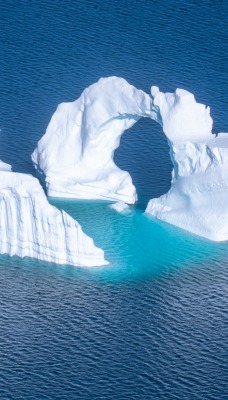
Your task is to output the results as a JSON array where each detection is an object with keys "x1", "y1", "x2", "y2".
[{"x1": 0, "y1": 164, "x2": 107, "y2": 266}]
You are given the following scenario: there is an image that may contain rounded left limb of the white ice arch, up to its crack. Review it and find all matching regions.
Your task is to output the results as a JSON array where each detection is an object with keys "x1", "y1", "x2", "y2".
[{"x1": 32, "y1": 77, "x2": 156, "y2": 203}]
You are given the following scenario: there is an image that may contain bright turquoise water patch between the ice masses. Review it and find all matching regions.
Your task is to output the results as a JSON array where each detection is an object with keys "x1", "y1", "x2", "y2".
[{"x1": 52, "y1": 200, "x2": 228, "y2": 281}]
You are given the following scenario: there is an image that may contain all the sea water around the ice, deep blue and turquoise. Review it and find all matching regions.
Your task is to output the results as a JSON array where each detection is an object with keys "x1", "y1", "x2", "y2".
[{"x1": 0, "y1": 0, "x2": 228, "y2": 400}]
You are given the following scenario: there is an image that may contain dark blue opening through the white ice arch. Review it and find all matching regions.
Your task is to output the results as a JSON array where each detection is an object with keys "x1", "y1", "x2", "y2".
[{"x1": 114, "y1": 118, "x2": 173, "y2": 210}]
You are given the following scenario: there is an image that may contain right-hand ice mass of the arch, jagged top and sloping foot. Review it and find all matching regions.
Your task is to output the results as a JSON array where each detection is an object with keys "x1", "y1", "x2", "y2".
[{"x1": 146, "y1": 90, "x2": 228, "y2": 241}]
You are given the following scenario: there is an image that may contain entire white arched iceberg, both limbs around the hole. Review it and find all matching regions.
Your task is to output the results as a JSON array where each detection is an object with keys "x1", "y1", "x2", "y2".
[{"x1": 32, "y1": 77, "x2": 228, "y2": 241}]
